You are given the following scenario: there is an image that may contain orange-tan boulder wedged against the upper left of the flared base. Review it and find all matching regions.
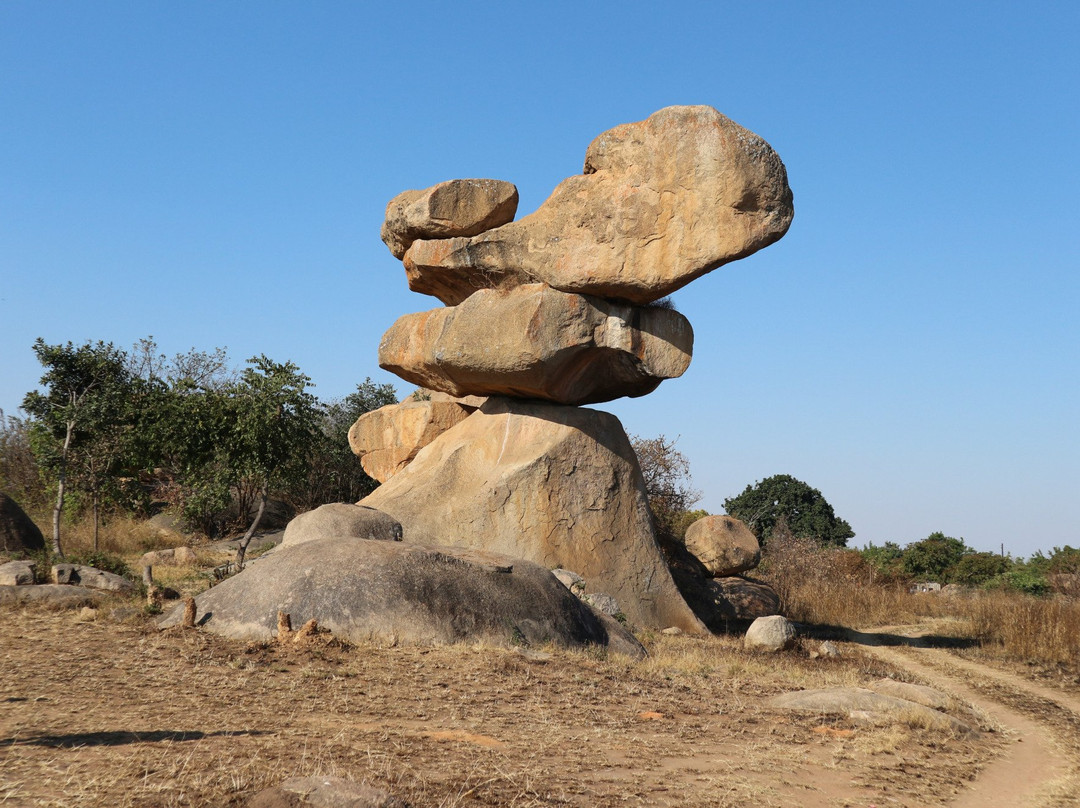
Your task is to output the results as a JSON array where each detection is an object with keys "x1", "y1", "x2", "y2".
[{"x1": 349, "y1": 390, "x2": 484, "y2": 483}]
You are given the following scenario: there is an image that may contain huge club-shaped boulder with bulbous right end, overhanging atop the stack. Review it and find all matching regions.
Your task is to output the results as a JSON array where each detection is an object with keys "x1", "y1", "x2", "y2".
[{"x1": 404, "y1": 106, "x2": 794, "y2": 305}]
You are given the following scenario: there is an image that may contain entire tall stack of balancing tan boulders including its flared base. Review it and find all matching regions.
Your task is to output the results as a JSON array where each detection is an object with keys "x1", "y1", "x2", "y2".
[{"x1": 350, "y1": 106, "x2": 793, "y2": 632}]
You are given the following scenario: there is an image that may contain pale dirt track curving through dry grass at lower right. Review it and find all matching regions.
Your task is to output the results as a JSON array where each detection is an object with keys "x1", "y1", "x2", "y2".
[{"x1": 853, "y1": 627, "x2": 1080, "y2": 808}]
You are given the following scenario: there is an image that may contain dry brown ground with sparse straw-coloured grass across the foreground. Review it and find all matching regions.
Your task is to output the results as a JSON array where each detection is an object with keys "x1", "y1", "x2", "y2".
[{"x1": 0, "y1": 603, "x2": 1080, "y2": 807}]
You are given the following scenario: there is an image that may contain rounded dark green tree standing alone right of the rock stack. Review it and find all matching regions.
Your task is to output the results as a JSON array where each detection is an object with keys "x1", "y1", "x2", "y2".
[{"x1": 724, "y1": 474, "x2": 855, "y2": 547}]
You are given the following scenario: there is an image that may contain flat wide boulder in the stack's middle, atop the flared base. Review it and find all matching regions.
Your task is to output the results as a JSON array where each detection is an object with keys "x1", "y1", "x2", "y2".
[{"x1": 379, "y1": 284, "x2": 693, "y2": 405}]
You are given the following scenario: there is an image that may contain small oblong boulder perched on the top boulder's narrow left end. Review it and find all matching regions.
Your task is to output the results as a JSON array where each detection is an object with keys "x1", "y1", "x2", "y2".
[{"x1": 382, "y1": 179, "x2": 517, "y2": 258}]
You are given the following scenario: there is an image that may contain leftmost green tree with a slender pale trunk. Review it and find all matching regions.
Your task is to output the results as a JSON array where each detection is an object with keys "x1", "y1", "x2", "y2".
[{"x1": 23, "y1": 337, "x2": 131, "y2": 556}]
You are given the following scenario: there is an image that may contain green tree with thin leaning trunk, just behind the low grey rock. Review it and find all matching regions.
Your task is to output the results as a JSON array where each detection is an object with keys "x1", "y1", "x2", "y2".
[{"x1": 227, "y1": 354, "x2": 319, "y2": 568}]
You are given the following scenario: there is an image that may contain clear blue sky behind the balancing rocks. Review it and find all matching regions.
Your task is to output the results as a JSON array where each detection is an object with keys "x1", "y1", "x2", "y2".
[{"x1": 0, "y1": 0, "x2": 1080, "y2": 555}]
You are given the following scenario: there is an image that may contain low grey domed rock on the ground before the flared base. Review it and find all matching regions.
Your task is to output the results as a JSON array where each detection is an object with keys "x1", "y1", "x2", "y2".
[{"x1": 161, "y1": 539, "x2": 644, "y2": 657}]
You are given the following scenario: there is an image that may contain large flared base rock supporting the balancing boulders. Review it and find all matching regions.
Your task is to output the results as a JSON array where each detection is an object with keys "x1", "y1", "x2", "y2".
[{"x1": 361, "y1": 399, "x2": 705, "y2": 633}]
